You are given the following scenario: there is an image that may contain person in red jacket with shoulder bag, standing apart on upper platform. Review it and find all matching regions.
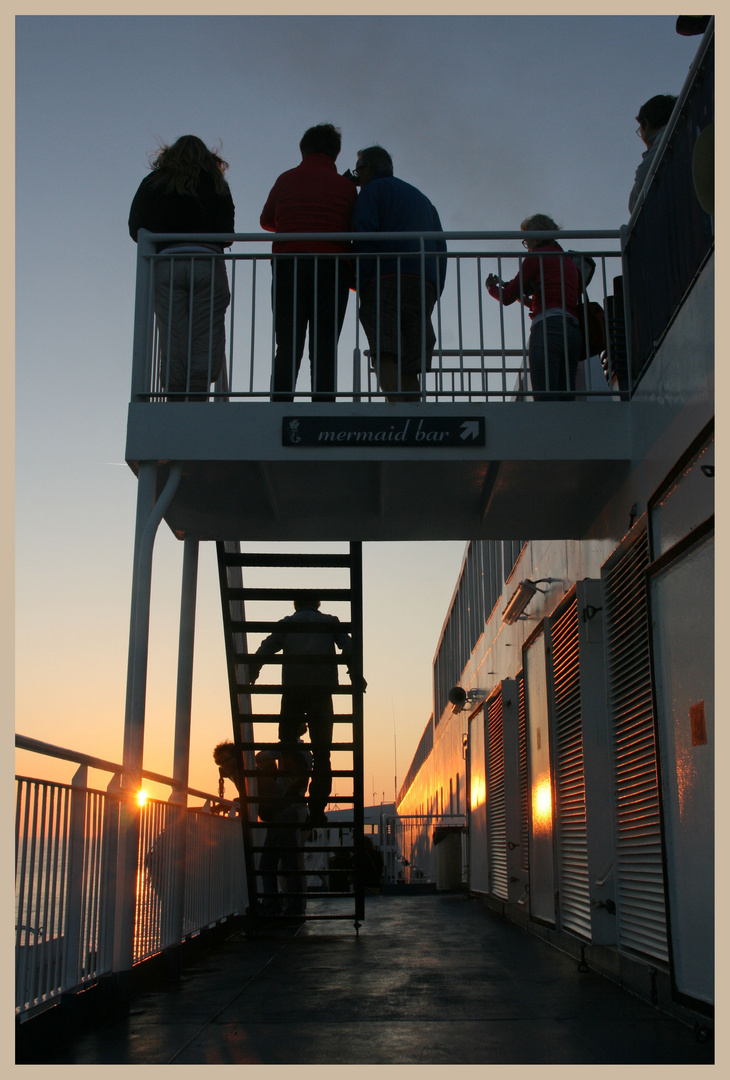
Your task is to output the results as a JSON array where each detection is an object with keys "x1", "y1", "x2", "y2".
[{"x1": 486, "y1": 214, "x2": 583, "y2": 401}]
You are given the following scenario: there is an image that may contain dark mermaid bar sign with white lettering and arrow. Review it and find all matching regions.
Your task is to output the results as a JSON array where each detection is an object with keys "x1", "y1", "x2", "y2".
[{"x1": 282, "y1": 416, "x2": 485, "y2": 448}]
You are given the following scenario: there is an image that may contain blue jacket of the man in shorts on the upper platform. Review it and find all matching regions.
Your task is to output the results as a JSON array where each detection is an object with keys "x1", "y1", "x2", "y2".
[{"x1": 352, "y1": 173, "x2": 447, "y2": 296}]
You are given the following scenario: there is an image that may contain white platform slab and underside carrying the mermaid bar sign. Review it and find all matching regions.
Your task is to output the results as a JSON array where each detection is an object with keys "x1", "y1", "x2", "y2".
[{"x1": 127, "y1": 401, "x2": 632, "y2": 540}]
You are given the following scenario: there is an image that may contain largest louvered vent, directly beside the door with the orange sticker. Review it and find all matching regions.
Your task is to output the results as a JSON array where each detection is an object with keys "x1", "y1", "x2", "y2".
[{"x1": 604, "y1": 531, "x2": 668, "y2": 963}]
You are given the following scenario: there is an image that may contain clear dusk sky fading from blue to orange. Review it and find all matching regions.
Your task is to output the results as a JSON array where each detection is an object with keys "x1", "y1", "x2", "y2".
[{"x1": 15, "y1": 9, "x2": 700, "y2": 804}]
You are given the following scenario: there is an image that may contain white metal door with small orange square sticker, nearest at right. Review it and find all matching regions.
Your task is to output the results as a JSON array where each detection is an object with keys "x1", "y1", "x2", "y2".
[{"x1": 650, "y1": 528, "x2": 715, "y2": 1003}]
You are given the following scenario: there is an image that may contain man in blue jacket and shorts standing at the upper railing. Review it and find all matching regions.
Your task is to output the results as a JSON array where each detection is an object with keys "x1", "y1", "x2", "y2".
[{"x1": 352, "y1": 146, "x2": 446, "y2": 402}]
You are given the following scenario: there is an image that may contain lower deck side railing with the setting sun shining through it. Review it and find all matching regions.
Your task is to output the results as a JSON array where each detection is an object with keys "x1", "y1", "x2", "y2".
[{"x1": 15, "y1": 735, "x2": 246, "y2": 1018}]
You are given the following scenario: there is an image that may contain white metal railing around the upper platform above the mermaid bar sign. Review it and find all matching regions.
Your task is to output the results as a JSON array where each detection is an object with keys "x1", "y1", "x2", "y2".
[{"x1": 132, "y1": 230, "x2": 624, "y2": 402}]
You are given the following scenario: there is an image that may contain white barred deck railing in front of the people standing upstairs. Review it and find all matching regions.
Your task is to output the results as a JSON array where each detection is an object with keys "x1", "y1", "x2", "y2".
[{"x1": 132, "y1": 230, "x2": 626, "y2": 402}]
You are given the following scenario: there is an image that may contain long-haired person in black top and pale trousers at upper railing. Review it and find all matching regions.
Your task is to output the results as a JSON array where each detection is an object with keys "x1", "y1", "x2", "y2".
[{"x1": 129, "y1": 135, "x2": 235, "y2": 401}]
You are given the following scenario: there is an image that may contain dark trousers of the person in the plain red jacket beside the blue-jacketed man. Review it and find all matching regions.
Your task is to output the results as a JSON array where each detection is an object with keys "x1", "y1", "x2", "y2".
[{"x1": 271, "y1": 256, "x2": 350, "y2": 402}]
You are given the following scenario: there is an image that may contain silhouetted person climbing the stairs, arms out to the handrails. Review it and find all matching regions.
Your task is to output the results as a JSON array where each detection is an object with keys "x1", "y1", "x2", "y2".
[{"x1": 248, "y1": 592, "x2": 366, "y2": 827}]
